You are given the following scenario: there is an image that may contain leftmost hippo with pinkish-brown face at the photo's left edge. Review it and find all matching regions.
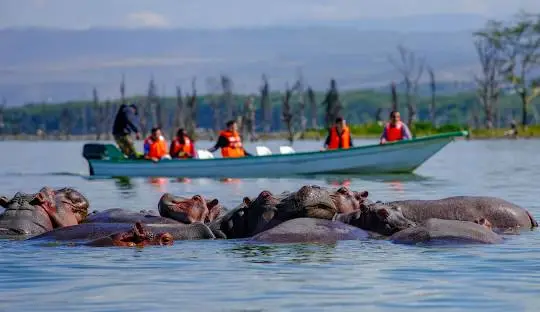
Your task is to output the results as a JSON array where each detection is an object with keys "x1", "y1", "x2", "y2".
[{"x1": 0, "y1": 187, "x2": 89, "y2": 235}]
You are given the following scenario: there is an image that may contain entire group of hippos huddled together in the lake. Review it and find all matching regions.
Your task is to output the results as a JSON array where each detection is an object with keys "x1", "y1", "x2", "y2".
[{"x1": 0, "y1": 185, "x2": 538, "y2": 247}]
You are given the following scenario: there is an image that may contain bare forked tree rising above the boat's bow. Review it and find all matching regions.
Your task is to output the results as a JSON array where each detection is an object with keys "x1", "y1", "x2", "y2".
[{"x1": 389, "y1": 45, "x2": 424, "y2": 127}]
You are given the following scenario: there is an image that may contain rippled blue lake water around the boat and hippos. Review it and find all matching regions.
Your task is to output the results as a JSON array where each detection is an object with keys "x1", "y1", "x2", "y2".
[{"x1": 0, "y1": 140, "x2": 540, "y2": 312}]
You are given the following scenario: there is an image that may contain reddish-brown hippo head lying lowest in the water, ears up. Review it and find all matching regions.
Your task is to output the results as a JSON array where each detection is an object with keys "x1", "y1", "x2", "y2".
[{"x1": 84, "y1": 222, "x2": 174, "y2": 247}]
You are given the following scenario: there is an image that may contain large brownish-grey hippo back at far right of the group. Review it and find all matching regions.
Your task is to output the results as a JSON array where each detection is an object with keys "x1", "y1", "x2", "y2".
[{"x1": 388, "y1": 196, "x2": 538, "y2": 231}]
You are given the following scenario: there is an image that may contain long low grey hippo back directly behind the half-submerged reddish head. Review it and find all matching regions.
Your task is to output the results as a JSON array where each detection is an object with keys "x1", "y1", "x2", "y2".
[{"x1": 29, "y1": 222, "x2": 215, "y2": 241}]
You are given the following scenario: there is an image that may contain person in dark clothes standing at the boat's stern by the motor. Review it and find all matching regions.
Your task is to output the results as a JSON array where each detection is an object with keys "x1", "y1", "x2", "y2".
[{"x1": 112, "y1": 104, "x2": 141, "y2": 158}]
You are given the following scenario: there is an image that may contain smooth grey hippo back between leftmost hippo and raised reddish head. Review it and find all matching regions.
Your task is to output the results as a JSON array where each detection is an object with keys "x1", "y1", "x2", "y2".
[{"x1": 84, "y1": 208, "x2": 181, "y2": 224}]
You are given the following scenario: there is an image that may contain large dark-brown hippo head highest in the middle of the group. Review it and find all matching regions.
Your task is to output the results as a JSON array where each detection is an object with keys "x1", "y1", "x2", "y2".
[{"x1": 277, "y1": 185, "x2": 338, "y2": 221}]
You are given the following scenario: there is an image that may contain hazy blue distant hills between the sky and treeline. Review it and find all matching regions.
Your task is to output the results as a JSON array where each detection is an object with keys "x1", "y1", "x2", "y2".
[{"x1": 0, "y1": 14, "x2": 486, "y2": 105}]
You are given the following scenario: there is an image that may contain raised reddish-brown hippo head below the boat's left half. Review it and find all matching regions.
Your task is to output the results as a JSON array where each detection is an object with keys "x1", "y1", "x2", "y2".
[{"x1": 158, "y1": 193, "x2": 209, "y2": 224}]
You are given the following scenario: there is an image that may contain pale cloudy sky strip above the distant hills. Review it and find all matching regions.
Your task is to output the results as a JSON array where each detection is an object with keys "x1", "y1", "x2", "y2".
[{"x1": 0, "y1": 0, "x2": 540, "y2": 29}]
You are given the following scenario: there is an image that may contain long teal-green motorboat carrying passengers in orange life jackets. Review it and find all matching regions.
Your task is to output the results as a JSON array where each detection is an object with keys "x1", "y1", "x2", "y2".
[{"x1": 83, "y1": 131, "x2": 467, "y2": 178}]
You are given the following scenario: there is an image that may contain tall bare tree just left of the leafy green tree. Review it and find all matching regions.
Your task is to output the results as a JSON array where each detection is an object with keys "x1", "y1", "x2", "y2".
[{"x1": 474, "y1": 38, "x2": 501, "y2": 129}]
